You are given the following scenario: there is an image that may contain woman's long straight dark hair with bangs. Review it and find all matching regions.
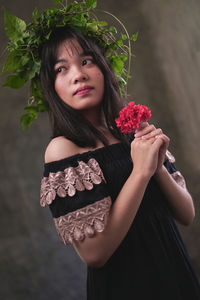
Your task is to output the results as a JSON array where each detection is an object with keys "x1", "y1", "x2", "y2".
[{"x1": 40, "y1": 27, "x2": 124, "y2": 148}]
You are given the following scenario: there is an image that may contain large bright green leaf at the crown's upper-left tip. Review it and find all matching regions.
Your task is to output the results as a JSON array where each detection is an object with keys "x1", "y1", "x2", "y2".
[{"x1": 4, "y1": 9, "x2": 26, "y2": 43}]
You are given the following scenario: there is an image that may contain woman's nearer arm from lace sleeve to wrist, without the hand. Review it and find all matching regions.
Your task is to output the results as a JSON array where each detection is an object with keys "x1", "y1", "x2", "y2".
[{"x1": 74, "y1": 171, "x2": 149, "y2": 267}]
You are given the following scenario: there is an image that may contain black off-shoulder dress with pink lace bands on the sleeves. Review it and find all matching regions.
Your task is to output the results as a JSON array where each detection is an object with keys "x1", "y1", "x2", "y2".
[{"x1": 40, "y1": 142, "x2": 200, "y2": 300}]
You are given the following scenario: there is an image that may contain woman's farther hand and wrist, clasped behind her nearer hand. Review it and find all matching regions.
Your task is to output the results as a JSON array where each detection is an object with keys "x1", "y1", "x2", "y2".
[{"x1": 135, "y1": 122, "x2": 170, "y2": 174}]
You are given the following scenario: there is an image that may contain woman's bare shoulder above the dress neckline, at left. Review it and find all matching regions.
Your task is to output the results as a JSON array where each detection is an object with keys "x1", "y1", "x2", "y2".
[{"x1": 44, "y1": 136, "x2": 80, "y2": 163}]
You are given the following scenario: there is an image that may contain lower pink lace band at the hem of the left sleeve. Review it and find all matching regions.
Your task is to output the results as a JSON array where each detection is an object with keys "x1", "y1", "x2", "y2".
[{"x1": 54, "y1": 197, "x2": 112, "y2": 244}]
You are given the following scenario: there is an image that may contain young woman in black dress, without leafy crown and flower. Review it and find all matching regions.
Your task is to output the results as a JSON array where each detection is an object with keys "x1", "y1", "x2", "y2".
[{"x1": 41, "y1": 27, "x2": 200, "y2": 300}]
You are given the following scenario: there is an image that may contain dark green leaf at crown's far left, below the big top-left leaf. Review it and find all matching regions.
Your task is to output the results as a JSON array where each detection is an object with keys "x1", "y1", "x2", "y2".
[{"x1": 2, "y1": 50, "x2": 29, "y2": 73}]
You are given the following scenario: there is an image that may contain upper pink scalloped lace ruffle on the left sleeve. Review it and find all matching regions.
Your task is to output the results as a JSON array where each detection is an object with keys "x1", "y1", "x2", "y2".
[{"x1": 40, "y1": 158, "x2": 106, "y2": 206}]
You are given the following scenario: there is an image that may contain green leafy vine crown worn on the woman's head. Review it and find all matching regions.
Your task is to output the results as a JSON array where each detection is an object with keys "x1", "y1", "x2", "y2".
[{"x1": 2, "y1": 0, "x2": 138, "y2": 129}]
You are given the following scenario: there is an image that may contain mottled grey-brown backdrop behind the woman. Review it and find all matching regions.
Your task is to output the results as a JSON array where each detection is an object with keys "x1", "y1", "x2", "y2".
[{"x1": 0, "y1": 0, "x2": 200, "y2": 300}]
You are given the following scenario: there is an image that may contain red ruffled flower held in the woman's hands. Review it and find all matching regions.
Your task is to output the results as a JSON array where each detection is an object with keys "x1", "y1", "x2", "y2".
[{"x1": 115, "y1": 101, "x2": 151, "y2": 133}]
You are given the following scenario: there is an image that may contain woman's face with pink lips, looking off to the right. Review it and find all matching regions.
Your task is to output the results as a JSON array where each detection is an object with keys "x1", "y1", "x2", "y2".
[{"x1": 54, "y1": 39, "x2": 104, "y2": 111}]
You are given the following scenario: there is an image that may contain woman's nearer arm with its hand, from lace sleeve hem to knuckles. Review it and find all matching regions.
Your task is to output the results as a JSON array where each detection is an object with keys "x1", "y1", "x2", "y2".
[{"x1": 74, "y1": 139, "x2": 163, "y2": 267}]
